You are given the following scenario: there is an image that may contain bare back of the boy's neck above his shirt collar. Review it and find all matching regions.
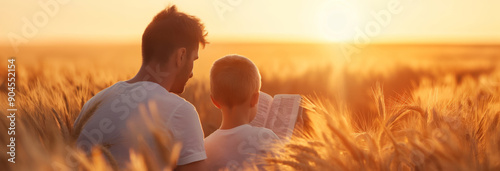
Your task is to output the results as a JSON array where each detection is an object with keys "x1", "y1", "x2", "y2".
[{"x1": 220, "y1": 105, "x2": 251, "y2": 129}]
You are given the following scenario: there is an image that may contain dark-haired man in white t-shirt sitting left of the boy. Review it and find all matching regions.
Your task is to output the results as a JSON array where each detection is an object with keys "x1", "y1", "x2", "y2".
[{"x1": 74, "y1": 6, "x2": 207, "y2": 170}]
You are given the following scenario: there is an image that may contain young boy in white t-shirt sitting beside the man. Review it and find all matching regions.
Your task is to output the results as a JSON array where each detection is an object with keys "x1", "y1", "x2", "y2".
[{"x1": 205, "y1": 55, "x2": 279, "y2": 170}]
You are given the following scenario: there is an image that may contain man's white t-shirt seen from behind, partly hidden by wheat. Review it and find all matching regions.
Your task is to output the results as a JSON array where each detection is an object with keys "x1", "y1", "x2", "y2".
[{"x1": 75, "y1": 81, "x2": 206, "y2": 168}]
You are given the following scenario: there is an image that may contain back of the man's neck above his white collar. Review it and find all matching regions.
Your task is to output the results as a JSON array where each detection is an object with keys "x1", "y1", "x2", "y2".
[{"x1": 125, "y1": 65, "x2": 174, "y2": 92}]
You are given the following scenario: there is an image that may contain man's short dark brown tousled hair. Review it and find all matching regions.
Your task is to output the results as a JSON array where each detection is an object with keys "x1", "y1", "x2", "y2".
[{"x1": 142, "y1": 5, "x2": 208, "y2": 64}]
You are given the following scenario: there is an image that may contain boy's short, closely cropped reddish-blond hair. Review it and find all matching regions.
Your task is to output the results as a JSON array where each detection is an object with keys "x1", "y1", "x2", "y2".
[{"x1": 210, "y1": 55, "x2": 261, "y2": 108}]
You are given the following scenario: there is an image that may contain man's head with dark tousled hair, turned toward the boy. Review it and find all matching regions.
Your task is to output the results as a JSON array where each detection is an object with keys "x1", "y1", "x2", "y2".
[{"x1": 142, "y1": 6, "x2": 208, "y2": 93}]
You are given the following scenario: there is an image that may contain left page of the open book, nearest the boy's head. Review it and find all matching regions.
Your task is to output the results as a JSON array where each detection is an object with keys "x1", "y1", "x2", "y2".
[{"x1": 250, "y1": 91, "x2": 273, "y2": 127}]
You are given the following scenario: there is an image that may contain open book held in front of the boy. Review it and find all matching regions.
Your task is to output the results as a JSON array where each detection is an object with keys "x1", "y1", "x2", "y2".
[{"x1": 250, "y1": 92, "x2": 302, "y2": 139}]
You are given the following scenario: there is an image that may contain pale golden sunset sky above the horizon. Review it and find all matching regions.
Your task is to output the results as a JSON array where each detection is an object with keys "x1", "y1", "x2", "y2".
[{"x1": 0, "y1": 0, "x2": 500, "y2": 44}]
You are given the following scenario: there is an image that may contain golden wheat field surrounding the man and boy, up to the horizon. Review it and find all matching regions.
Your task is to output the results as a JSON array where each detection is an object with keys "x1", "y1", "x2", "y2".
[{"x1": 0, "y1": 44, "x2": 500, "y2": 170}]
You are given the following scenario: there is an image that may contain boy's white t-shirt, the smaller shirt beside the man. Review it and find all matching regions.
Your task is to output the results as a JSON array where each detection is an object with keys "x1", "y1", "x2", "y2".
[{"x1": 205, "y1": 124, "x2": 279, "y2": 170}]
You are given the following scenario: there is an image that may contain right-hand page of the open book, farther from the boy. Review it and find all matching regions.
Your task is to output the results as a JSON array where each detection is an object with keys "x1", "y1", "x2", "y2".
[{"x1": 266, "y1": 94, "x2": 302, "y2": 139}]
